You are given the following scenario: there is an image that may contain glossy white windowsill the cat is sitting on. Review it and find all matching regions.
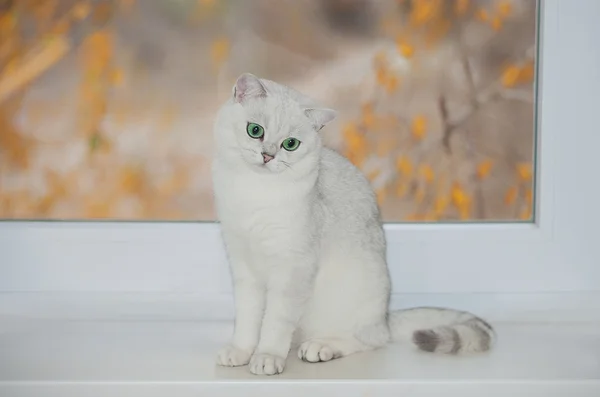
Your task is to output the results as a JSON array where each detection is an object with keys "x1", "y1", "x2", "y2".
[{"x1": 0, "y1": 316, "x2": 600, "y2": 397}]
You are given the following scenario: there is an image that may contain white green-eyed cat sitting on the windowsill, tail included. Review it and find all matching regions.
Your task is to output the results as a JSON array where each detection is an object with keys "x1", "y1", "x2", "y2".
[{"x1": 213, "y1": 73, "x2": 495, "y2": 375}]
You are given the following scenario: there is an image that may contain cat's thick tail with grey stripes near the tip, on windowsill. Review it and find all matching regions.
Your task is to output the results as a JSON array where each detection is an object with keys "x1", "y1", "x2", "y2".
[{"x1": 388, "y1": 307, "x2": 496, "y2": 354}]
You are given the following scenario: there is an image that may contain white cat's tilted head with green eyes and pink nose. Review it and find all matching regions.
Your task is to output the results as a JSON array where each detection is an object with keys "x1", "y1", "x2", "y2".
[{"x1": 217, "y1": 73, "x2": 336, "y2": 174}]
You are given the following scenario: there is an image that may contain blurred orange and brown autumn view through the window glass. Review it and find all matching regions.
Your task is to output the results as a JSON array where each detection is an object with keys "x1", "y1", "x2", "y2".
[{"x1": 0, "y1": 0, "x2": 537, "y2": 222}]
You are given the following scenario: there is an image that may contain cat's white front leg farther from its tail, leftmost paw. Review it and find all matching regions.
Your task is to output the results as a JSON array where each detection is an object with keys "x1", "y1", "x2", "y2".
[{"x1": 217, "y1": 238, "x2": 265, "y2": 367}]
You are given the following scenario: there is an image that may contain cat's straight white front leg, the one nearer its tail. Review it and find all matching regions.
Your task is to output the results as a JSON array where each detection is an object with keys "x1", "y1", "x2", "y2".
[{"x1": 250, "y1": 259, "x2": 314, "y2": 375}]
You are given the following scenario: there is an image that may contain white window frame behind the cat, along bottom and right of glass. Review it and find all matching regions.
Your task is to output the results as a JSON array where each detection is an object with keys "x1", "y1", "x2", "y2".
[{"x1": 0, "y1": 0, "x2": 600, "y2": 319}]
